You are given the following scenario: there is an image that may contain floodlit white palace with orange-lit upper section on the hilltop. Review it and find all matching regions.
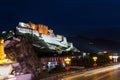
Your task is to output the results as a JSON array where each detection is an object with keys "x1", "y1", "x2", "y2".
[{"x1": 16, "y1": 22, "x2": 73, "y2": 51}]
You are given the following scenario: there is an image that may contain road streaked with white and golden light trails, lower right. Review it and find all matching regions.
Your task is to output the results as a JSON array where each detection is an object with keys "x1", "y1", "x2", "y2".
[{"x1": 60, "y1": 64, "x2": 120, "y2": 80}]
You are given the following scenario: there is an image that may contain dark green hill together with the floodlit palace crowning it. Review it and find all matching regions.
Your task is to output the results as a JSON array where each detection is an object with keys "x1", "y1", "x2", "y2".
[{"x1": 2, "y1": 22, "x2": 77, "y2": 53}]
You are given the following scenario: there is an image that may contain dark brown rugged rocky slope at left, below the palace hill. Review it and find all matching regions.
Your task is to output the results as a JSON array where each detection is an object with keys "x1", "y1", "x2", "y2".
[{"x1": 5, "y1": 36, "x2": 41, "y2": 79}]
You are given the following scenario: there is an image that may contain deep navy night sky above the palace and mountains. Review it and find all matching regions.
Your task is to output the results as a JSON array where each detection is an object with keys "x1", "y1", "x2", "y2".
[{"x1": 0, "y1": 0, "x2": 120, "y2": 40}]
